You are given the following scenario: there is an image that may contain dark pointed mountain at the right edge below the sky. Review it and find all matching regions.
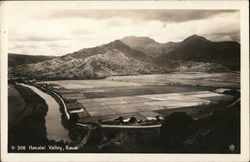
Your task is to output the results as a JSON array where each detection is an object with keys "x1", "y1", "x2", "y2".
[{"x1": 156, "y1": 35, "x2": 240, "y2": 70}]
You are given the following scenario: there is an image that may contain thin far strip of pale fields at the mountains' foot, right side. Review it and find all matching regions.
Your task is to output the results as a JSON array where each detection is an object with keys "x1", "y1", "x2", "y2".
[{"x1": 107, "y1": 73, "x2": 240, "y2": 88}]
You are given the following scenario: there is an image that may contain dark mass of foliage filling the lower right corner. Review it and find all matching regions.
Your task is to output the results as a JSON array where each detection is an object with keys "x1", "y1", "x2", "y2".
[{"x1": 159, "y1": 98, "x2": 240, "y2": 153}]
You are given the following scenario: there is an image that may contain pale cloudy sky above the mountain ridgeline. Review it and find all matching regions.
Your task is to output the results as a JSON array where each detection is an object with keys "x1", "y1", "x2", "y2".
[{"x1": 7, "y1": 9, "x2": 240, "y2": 56}]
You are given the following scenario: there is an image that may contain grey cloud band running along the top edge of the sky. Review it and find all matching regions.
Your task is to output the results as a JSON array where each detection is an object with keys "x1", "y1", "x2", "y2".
[{"x1": 46, "y1": 10, "x2": 237, "y2": 22}]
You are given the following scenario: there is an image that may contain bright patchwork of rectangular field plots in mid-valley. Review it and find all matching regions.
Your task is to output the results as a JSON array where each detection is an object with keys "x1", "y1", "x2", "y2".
[{"x1": 74, "y1": 91, "x2": 232, "y2": 122}]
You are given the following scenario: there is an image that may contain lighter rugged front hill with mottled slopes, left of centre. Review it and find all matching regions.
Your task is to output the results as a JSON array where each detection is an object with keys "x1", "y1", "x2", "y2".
[{"x1": 10, "y1": 49, "x2": 168, "y2": 80}]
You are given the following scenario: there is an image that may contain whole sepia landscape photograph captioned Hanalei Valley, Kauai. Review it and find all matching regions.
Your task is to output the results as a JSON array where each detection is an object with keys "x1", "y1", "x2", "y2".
[{"x1": 1, "y1": 2, "x2": 249, "y2": 160}]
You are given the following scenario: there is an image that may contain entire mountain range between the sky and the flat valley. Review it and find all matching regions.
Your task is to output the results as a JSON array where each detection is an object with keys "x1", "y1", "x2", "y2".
[{"x1": 9, "y1": 35, "x2": 240, "y2": 79}]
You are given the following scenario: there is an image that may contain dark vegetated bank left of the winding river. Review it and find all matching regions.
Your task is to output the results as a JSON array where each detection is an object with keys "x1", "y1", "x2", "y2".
[{"x1": 8, "y1": 85, "x2": 48, "y2": 148}]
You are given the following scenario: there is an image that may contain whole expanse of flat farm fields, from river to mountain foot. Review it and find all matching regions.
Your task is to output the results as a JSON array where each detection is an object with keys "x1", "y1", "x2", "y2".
[{"x1": 40, "y1": 73, "x2": 240, "y2": 123}]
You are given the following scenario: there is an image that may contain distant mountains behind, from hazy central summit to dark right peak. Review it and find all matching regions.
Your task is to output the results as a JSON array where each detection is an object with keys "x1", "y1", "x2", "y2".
[{"x1": 121, "y1": 35, "x2": 240, "y2": 70}]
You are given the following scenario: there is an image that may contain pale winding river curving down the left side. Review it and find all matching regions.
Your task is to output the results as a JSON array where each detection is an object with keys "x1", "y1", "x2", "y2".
[{"x1": 18, "y1": 84, "x2": 71, "y2": 142}]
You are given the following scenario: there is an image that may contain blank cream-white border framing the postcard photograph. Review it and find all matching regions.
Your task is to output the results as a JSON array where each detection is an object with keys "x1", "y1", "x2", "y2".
[{"x1": 0, "y1": 0, "x2": 249, "y2": 162}]
